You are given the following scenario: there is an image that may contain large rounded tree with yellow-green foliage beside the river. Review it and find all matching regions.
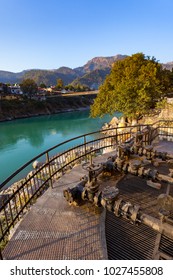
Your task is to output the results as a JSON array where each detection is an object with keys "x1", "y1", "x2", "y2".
[{"x1": 91, "y1": 53, "x2": 171, "y2": 118}]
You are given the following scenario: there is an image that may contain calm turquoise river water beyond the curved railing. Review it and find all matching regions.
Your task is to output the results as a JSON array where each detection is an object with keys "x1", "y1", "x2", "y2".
[{"x1": 0, "y1": 110, "x2": 118, "y2": 183}]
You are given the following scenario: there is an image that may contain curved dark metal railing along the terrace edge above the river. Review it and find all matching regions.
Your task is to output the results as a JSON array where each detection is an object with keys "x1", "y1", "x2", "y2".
[{"x1": 0, "y1": 121, "x2": 173, "y2": 258}]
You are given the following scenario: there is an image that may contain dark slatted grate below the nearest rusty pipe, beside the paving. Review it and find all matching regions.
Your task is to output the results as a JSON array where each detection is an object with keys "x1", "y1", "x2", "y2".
[{"x1": 105, "y1": 211, "x2": 157, "y2": 260}]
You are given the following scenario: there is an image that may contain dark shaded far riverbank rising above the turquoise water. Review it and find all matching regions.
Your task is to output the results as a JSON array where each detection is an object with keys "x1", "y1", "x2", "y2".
[{"x1": 0, "y1": 94, "x2": 96, "y2": 122}]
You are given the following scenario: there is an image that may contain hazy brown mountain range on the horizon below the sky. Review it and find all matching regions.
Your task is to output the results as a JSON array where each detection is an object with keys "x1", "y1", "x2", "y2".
[{"x1": 0, "y1": 54, "x2": 173, "y2": 89}]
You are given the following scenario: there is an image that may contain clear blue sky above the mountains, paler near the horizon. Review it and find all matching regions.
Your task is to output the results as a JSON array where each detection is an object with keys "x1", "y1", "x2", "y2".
[{"x1": 0, "y1": 0, "x2": 173, "y2": 72}]
